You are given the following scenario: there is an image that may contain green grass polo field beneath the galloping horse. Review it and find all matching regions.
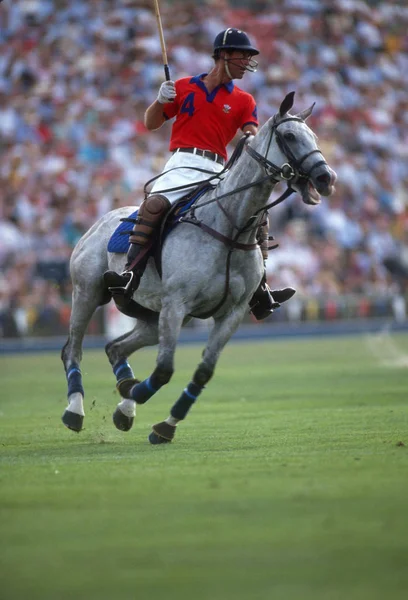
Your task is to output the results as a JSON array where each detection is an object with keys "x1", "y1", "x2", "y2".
[{"x1": 0, "y1": 335, "x2": 408, "y2": 600}]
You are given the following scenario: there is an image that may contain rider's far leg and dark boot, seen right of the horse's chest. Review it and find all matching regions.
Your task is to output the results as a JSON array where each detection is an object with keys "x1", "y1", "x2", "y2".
[{"x1": 249, "y1": 218, "x2": 296, "y2": 321}]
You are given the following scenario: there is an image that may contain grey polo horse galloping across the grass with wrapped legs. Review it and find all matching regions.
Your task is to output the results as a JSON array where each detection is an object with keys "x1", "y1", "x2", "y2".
[{"x1": 61, "y1": 92, "x2": 336, "y2": 444}]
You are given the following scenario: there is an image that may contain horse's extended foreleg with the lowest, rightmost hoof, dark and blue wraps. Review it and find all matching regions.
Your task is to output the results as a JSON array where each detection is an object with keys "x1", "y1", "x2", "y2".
[{"x1": 149, "y1": 305, "x2": 247, "y2": 444}]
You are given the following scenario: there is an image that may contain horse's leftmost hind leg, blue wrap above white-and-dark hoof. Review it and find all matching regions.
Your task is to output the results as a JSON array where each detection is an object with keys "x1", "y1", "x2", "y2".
[{"x1": 61, "y1": 287, "x2": 101, "y2": 432}]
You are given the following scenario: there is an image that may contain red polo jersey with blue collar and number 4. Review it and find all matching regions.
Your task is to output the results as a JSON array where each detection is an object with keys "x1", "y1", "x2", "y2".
[{"x1": 163, "y1": 73, "x2": 258, "y2": 159}]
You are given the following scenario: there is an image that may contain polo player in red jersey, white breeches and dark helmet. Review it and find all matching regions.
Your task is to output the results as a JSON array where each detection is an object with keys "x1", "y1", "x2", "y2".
[{"x1": 104, "y1": 28, "x2": 295, "y2": 319}]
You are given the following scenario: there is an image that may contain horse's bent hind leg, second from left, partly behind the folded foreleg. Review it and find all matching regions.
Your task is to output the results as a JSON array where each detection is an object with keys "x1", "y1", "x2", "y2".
[{"x1": 105, "y1": 319, "x2": 159, "y2": 431}]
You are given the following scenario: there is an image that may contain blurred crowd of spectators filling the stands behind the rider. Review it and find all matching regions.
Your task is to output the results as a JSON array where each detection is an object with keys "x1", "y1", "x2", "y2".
[{"x1": 0, "y1": 0, "x2": 408, "y2": 336}]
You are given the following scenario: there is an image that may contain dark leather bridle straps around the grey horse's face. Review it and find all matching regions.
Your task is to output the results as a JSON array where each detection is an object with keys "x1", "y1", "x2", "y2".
[{"x1": 246, "y1": 117, "x2": 328, "y2": 183}]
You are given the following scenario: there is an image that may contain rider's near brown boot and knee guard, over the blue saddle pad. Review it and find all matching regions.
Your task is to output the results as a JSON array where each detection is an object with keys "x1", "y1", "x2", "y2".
[{"x1": 103, "y1": 194, "x2": 171, "y2": 297}]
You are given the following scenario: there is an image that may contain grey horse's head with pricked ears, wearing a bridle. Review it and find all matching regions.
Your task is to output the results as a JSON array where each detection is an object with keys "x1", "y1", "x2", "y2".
[{"x1": 250, "y1": 92, "x2": 336, "y2": 204}]
